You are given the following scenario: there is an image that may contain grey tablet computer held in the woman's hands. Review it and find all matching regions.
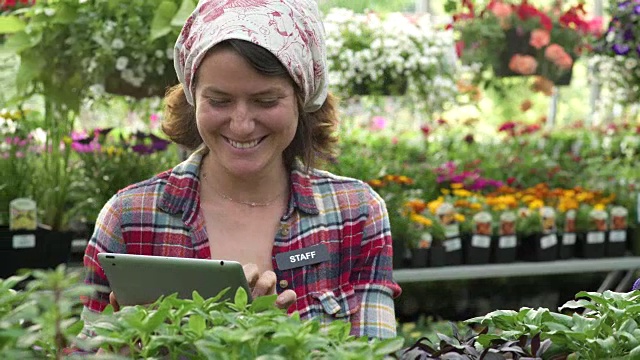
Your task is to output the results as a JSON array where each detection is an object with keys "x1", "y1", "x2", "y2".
[{"x1": 98, "y1": 253, "x2": 251, "y2": 306}]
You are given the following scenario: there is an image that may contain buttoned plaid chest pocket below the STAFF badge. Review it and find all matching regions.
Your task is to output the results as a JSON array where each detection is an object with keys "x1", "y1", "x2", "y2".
[{"x1": 307, "y1": 284, "x2": 360, "y2": 320}]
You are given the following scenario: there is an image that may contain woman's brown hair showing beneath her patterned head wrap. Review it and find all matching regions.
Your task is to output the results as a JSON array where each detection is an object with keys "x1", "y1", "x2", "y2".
[{"x1": 162, "y1": 40, "x2": 338, "y2": 170}]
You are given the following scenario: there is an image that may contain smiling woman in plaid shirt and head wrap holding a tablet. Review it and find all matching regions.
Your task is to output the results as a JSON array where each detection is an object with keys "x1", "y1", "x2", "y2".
[{"x1": 84, "y1": 0, "x2": 400, "y2": 338}]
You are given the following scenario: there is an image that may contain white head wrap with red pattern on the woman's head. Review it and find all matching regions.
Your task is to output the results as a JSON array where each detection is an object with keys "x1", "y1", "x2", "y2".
[{"x1": 174, "y1": 0, "x2": 328, "y2": 112}]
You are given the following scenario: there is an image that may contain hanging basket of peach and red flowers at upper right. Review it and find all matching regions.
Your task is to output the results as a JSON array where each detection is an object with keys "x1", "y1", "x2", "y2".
[{"x1": 448, "y1": 0, "x2": 599, "y2": 85}]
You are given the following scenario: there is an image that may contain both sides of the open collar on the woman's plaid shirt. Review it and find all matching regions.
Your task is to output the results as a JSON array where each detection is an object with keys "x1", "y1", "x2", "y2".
[{"x1": 158, "y1": 147, "x2": 320, "y2": 225}]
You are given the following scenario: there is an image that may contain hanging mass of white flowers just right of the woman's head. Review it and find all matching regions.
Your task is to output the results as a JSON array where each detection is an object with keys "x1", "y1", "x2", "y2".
[{"x1": 324, "y1": 8, "x2": 457, "y2": 111}]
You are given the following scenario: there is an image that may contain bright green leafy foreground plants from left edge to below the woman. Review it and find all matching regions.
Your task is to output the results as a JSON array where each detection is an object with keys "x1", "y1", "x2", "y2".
[{"x1": 0, "y1": 266, "x2": 403, "y2": 359}]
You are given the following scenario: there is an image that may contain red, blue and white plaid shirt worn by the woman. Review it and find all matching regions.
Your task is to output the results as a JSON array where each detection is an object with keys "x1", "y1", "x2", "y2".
[{"x1": 84, "y1": 151, "x2": 401, "y2": 338}]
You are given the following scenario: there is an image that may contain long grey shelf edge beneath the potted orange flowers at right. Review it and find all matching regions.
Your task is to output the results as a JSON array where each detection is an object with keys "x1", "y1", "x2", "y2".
[{"x1": 393, "y1": 256, "x2": 640, "y2": 283}]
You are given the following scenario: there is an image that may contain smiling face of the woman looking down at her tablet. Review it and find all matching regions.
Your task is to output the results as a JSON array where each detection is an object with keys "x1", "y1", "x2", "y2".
[{"x1": 195, "y1": 48, "x2": 298, "y2": 176}]
